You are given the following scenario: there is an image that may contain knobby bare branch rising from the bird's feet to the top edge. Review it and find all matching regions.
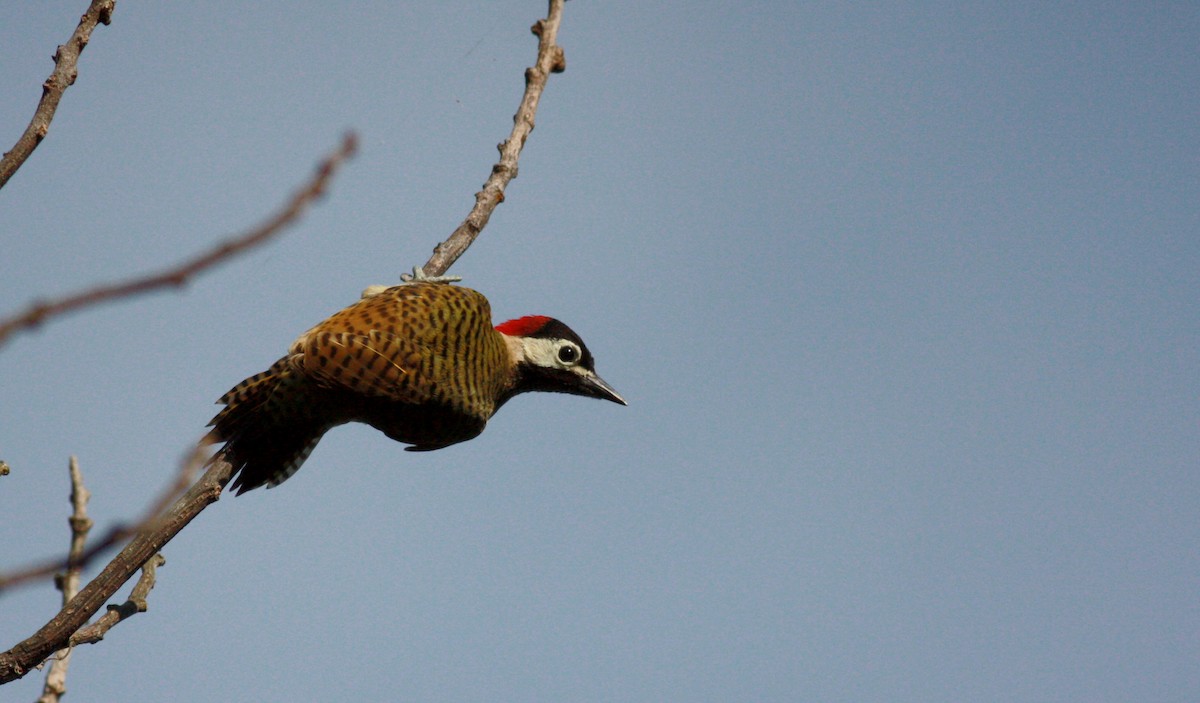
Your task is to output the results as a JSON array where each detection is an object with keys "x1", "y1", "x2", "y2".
[{"x1": 424, "y1": 0, "x2": 566, "y2": 276}]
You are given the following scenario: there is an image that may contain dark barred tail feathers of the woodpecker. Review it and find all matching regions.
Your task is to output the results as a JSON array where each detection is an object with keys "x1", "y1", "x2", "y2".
[{"x1": 206, "y1": 357, "x2": 330, "y2": 495}]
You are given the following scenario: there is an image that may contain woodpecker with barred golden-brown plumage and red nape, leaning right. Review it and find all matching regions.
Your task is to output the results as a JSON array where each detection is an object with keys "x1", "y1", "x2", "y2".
[{"x1": 206, "y1": 270, "x2": 626, "y2": 494}]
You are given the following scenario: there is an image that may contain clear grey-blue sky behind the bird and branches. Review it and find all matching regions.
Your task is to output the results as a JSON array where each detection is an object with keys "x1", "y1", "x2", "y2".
[{"x1": 0, "y1": 0, "x2": 1200, "y2": 703}]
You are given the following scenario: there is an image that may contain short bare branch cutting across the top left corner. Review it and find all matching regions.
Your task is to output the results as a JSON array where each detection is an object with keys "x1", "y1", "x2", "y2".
[{"x1": 0, "y1": 0, "x2": 116, "y2": 188}]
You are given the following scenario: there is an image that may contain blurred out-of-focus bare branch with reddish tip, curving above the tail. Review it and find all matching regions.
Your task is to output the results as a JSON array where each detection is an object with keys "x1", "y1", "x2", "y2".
[{"x1": 0, "y1": 133, "x2": 358, "y2": 346}]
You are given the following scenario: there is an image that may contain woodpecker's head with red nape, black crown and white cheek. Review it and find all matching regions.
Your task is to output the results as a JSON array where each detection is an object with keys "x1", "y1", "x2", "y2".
[{"x1": 496, "y1": 316, "x2": 626, "y2": 405}]
